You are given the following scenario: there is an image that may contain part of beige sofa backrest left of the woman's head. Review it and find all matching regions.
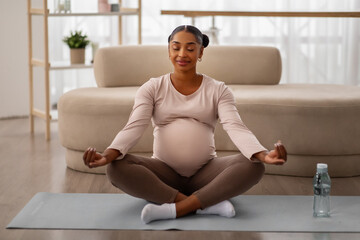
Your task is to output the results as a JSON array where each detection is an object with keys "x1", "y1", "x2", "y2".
[{"x1": 94, "y1": 45, "x2": 172, "y2": 87}]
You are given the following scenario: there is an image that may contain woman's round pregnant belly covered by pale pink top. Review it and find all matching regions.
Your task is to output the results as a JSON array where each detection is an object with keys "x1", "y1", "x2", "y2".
[{"x1": 154, "y1": 118, "x2": 215, "y2": 177}]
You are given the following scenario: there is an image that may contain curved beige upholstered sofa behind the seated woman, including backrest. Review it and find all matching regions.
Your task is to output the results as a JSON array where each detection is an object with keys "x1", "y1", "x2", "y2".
[{"x1": 58, "y1": 46, "x2": 360, "y2": 177}]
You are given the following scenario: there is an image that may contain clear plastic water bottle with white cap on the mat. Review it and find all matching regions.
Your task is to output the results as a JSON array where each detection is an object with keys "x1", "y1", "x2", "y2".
[{"x1": 313, "y1": 163, "x2": 331, "y2": 217}]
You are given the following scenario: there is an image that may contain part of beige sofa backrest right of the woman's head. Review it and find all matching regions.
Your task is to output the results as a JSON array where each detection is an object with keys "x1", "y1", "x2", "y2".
[{"x1": 197, "y1": 46, "x2": 281, "y2": 85}]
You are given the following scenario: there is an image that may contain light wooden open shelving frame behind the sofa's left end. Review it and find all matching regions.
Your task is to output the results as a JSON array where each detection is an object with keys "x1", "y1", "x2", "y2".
[{"x1": 27, "y1": 0, "x2": 141, "y2": 140}]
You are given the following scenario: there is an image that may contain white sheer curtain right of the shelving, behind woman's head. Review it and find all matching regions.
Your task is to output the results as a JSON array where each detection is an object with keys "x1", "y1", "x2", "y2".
[{"x1": 139, "y1": 0, "x2": 360, "y2": 85}]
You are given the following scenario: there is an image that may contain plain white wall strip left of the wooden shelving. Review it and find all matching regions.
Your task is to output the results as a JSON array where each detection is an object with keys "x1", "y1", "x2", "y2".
[{"x1": 0, "y1": 0, "x2": 29, "y2": 118}]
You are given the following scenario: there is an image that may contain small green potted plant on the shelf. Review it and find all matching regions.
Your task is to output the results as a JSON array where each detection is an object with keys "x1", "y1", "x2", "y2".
[{"x1": 63, "y1": 31, "x2": 90, "y2": 64}]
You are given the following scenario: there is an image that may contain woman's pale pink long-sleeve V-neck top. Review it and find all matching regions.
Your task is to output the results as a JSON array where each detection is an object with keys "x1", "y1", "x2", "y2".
[{"x1": 109, "y1": 74, "x2": 266, "y2": 177}]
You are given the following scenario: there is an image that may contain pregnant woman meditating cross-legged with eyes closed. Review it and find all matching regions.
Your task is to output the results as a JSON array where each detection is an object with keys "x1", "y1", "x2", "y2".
[{"x1": 83, "y1": 25, "x2": 287, "y2": 223}]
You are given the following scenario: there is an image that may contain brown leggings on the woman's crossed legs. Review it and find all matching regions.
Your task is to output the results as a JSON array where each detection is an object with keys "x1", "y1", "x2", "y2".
[{"x1": 107, "y1": 154, "x2": 265, "y2": 208}]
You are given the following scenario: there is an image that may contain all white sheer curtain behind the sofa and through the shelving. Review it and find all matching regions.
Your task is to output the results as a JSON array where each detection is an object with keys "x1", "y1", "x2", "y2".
[{"x1": 49, "y1": 0, "x2": 360, "y2": 108}]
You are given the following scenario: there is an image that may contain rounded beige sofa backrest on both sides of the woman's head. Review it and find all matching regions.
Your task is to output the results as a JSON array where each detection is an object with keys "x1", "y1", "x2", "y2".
[{"x1": 94, "y1": 46, "x2": 281, "y2": 87}]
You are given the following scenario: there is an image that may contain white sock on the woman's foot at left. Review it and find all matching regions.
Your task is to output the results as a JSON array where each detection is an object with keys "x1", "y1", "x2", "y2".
[{"x1": 141, "y1": 203, "x2": 176, "y2": 223}]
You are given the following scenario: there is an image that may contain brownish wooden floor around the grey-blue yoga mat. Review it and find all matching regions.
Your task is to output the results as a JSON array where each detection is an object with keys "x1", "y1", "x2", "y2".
[{"x1": 0, "y1": 118, "x2": 360, "y2": 240}]
